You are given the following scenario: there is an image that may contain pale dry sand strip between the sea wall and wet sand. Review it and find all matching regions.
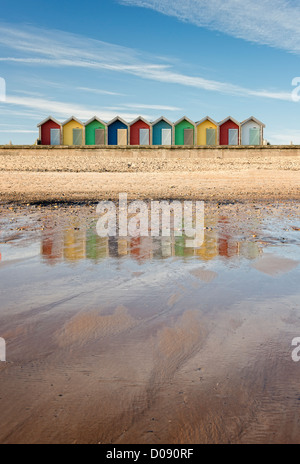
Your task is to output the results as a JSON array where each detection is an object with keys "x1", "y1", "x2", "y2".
[{"x1": 0, "y1": 154, "x2": 300, "y2": 203}]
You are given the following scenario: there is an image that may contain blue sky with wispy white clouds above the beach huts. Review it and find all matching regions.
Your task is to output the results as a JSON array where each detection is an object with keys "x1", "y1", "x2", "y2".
[{"x1": 0, "y1": 0, "x2": 300, "y2": 144}]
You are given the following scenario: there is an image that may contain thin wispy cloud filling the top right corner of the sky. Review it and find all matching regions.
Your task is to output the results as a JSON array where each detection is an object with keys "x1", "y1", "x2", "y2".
[{"x1": 119, "y1": 0, "x2": 300, "y2": 53}]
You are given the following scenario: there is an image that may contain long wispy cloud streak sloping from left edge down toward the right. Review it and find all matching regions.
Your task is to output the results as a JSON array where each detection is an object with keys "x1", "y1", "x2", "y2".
[{"x1": 0, "y1": 22, "x2": 292, "y2": 102}]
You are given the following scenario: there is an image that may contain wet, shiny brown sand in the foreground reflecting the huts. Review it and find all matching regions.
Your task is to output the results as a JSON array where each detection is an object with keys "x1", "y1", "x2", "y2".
[{"x1": 0, "y1": 202, "x2": 300, "y2": 444}]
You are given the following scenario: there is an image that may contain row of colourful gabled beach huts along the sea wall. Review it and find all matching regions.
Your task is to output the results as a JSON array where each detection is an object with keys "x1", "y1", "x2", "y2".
[{"x1": 38, "y1": 116, "x2": 265, "y2": 146}]
